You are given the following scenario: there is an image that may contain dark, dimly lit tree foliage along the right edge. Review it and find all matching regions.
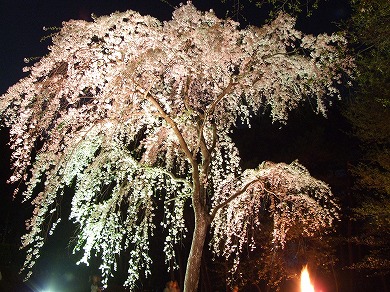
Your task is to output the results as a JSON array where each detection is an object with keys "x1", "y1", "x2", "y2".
[{"x1": 345, "y1": 0, "x2": 390, "y2": 275}]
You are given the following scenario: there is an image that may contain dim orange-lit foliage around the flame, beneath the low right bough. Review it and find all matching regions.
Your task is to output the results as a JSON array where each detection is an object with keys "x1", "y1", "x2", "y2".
[{"x1": 208, "y1": 208, "x2": 335, "y2": 291}]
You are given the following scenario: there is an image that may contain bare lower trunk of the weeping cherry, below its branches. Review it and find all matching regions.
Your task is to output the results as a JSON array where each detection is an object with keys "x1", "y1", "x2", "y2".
[{"x1": 184, "y1": 212, "x2": 210, "y2": 292}]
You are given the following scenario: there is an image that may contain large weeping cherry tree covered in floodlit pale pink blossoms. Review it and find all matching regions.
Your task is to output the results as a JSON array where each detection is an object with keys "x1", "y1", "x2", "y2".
[{"x1": 0, "y1": 3, "x2": 352, "y2": 291}]
